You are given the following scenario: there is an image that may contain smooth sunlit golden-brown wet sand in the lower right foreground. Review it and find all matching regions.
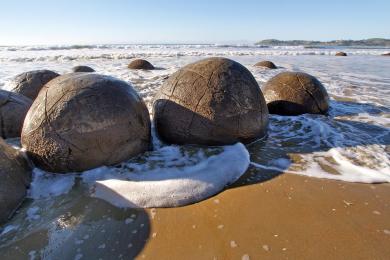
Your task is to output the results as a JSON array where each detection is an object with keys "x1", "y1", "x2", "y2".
[{"x1": 137, "y1": 174, "x2": 390, "y2": 259}]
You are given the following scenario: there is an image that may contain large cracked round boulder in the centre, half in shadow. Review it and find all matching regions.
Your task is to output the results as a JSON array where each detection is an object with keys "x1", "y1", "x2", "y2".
[{"x1": 153, "y1": 58, "x2": 268, "y2": 145}]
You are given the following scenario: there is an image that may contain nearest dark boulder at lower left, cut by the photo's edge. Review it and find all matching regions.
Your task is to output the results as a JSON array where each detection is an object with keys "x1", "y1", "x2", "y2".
[{"x1": 0, "y1": 138, "x2": 31, "y2": 224}]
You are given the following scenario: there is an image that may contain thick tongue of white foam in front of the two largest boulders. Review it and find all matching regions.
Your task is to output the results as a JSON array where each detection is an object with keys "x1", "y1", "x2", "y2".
[{"x1": 84, "y1": 143, "x2": 249, "y2": 207}]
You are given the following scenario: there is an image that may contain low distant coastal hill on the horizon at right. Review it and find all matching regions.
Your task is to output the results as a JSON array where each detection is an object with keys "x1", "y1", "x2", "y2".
[{"x1": 255, "y1": 38, "x2": 390, "y2": 47}]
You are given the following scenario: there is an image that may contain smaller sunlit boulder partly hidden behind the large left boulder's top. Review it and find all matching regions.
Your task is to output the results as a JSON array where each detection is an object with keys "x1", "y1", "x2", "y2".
[{"x1": 11, "y1": 70, "x2": 59, "y2": 100}]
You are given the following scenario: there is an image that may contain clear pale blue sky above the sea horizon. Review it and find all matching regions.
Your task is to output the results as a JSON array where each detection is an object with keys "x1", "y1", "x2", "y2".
[{"x1": 0, "y1": 0, "x2": 390, "y2": 45}]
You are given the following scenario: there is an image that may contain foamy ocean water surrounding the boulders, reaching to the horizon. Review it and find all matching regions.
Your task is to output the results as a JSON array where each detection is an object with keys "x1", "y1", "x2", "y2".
[{"x1": 0, "y1": 45, "x2": 390, "y2": 259}]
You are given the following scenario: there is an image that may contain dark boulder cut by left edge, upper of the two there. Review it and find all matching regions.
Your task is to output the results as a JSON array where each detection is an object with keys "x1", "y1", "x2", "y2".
[{"x1": 0, "y1": 89, "x2": 32, "y2": 138}]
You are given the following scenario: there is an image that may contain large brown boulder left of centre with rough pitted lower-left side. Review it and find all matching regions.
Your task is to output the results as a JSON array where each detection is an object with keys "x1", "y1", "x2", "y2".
[{"x1": 21, "y1": 73, "x2": 150, "y2": 173}]
